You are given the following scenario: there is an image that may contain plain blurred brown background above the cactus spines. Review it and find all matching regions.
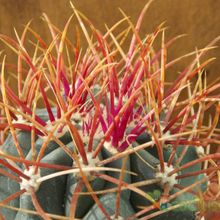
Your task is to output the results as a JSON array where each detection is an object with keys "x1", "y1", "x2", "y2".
[{"x1": 0, "y1": 0, "x2": 220, "y2": 85}]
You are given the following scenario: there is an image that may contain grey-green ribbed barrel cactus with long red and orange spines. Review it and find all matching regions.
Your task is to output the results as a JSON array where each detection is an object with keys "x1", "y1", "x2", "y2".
[{"x1": 0, "y1": 1, "x2": 220, "y2": 220}]
